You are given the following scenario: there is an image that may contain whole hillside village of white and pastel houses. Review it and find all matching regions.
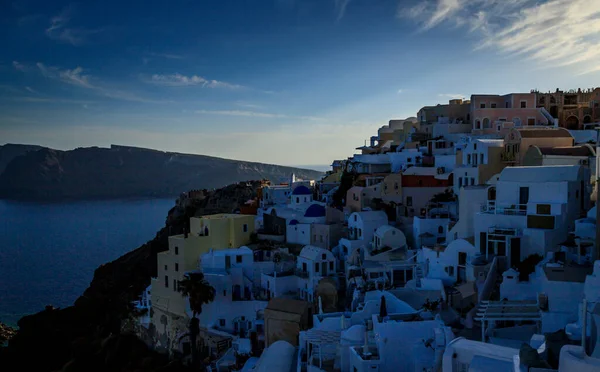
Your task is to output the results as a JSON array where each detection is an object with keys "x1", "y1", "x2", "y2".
[{"x1": 134, "y1": 88, "x2": 600, "y2": 372}]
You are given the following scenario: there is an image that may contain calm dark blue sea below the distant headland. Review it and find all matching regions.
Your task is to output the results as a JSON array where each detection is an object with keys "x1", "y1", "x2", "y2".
[{"x1": 0, "y1": 198, "x2": 175, "y2": 325}]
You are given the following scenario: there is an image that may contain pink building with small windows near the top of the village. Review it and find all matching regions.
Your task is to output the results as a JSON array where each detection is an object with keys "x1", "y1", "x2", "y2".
[{"x1": 471, "y1": 93, "x2": 554, "y2": 134}]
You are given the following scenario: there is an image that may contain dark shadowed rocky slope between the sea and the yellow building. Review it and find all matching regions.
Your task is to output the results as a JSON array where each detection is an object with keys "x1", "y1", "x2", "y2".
[{"x1": 0, "y1": 181, "x2": 260, "y2": 371}]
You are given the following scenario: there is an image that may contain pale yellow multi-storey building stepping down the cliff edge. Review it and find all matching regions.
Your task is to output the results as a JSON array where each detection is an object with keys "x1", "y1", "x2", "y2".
[{"x1": 151, "y1": 214, "x2": 255, "y2": 348}]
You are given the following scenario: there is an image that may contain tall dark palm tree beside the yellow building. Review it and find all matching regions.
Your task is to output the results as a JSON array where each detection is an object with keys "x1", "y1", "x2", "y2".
[{"x1": 177, "y1": 273, "x2": 215, "y2": 366}]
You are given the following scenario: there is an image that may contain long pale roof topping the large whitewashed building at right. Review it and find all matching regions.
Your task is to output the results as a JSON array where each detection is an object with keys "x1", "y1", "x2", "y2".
[{"x1": 500, "y1": 165, "x2": 581, "y2": 183}]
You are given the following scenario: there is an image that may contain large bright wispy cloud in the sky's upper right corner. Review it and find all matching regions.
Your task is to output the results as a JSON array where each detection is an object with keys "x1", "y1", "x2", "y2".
[{"x1": 398, "y1": 0, "x2": 600, "y2": 73}]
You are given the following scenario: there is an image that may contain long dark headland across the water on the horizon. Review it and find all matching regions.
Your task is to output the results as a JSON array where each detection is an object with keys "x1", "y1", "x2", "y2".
[{"x1": 0, "y1": 146, "x2": 321, "y2": 200}]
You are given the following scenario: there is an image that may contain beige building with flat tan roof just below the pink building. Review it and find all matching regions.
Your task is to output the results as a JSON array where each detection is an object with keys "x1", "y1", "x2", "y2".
[{"x1": 502, "y1": 128, "x2": 575, "y2": 166}]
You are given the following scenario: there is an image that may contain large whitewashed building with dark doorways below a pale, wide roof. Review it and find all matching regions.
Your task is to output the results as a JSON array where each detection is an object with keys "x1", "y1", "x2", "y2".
[{"x1": 474, "y1": 166, "x2": 588, "y2": 267}]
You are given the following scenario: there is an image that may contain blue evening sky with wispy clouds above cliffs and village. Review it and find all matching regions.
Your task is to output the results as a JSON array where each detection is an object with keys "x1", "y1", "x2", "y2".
[{"x1": 0, "y1": 0, "x2": 600, "y2": 165}]
